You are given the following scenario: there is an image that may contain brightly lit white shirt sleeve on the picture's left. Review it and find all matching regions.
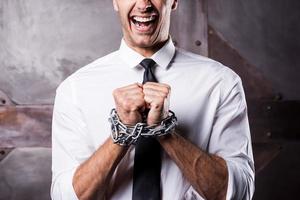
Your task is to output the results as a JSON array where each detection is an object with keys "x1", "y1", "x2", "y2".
[{"x1": 51, "y1": 79, "x2": 91, "y2": 200}]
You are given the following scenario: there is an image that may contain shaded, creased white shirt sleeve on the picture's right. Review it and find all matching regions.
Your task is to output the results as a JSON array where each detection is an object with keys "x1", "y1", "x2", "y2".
[{"x1": 209, "y1": 69, "x2": 254, "y2": 200}]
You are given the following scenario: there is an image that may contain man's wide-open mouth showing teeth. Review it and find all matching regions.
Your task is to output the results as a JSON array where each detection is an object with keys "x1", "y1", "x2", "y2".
[{"x1": 130, "y1": 15, "x2": 158, "y2": 32}]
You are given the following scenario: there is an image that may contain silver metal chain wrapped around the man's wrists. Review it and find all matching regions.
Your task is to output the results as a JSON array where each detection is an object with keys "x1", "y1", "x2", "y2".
[{"x1": 108, "y1": 109, "x2": 177, "y2": 146}]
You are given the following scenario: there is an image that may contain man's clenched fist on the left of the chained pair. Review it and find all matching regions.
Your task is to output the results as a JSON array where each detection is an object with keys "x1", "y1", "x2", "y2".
[{"x1": 113, "y1": 83, "x2": 145, "y2": 125}]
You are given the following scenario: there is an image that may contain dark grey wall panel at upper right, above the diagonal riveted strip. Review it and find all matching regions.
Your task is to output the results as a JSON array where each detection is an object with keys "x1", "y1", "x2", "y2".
[{"x1": 207, "y1": 0, "x2": 300, "y2": 100}]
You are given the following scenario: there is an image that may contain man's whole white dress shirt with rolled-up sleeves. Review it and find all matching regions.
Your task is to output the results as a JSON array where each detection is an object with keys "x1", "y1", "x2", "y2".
[{"x1": 51, "y1": 39, "x2": 254, "y2": 200}]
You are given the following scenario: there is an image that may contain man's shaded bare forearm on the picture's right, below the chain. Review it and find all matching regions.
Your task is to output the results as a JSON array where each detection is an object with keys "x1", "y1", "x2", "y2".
[{"x1": 159, "y1": 134, "x2": 228, "y2": 199}]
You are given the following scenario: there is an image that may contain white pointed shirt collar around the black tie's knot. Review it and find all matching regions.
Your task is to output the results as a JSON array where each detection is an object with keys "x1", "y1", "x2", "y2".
[{"x1": 119, "y1": 38, "x2": 175, "y2": 69}]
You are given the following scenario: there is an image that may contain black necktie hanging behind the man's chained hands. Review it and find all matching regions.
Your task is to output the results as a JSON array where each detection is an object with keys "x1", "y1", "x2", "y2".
[{"x1": 132, "y1": 59, "x2": 161, "y2": 200}]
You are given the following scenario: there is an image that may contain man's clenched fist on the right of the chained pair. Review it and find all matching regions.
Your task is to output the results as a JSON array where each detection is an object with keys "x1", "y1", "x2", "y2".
[{"x1": 143, "y1": 82, "x2": 171, "y2": 125}]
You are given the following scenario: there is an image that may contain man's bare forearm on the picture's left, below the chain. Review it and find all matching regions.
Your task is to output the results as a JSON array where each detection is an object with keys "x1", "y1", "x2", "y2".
[{"x1": 73, "y1": 138, "x2": 127, "y2": 199}]
